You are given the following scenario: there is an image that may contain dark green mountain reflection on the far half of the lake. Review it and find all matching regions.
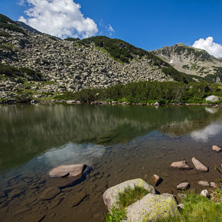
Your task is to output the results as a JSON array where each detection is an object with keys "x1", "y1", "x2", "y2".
[{"x1": 0, "y1": 104, "x2": 222, "y2": 172}]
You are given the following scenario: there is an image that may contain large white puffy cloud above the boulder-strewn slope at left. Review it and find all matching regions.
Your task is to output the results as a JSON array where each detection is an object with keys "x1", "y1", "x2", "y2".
[{"x1": 19, "y1": 0, "x2": 98, "y2": 38}]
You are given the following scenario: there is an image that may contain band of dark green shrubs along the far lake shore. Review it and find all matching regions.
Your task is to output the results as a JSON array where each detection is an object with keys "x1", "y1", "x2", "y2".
[{"x1": 62, "y1": 81, "x2": 222, "y2": 104}]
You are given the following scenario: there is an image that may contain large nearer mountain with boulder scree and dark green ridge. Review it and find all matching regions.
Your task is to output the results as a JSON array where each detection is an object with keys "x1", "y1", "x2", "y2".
[{"x1": 0, "y1": 14, "x2": 220, "y2": 101}]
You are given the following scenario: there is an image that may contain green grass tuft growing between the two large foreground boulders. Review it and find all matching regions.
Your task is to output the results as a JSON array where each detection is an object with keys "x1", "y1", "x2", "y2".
[{"x1": 106, "y1": 186, "x2": 149, "y2": 222}]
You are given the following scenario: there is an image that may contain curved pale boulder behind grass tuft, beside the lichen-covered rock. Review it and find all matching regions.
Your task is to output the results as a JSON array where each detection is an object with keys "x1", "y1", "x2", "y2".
[{"x1": 103, "y1": 179, "x2": 156, "y2": 211}]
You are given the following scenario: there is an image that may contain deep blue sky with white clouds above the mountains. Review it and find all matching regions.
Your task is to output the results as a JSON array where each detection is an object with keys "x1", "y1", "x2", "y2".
[{"x1": 0, "y1": 0, "x2": 222, "y2": 57}]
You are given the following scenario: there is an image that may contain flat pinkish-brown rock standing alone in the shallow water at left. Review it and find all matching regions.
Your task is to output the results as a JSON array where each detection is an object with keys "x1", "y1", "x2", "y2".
[{"x1": 49, "y1": 164, "x2": 86, "y2": 177}]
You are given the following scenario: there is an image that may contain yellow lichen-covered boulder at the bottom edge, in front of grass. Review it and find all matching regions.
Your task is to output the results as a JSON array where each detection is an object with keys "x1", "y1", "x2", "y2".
[{"x1": 126, "y1": 194, "x2": 179, "y2": 222}]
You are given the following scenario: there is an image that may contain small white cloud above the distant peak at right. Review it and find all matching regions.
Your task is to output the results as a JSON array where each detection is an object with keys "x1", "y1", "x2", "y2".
[{"x1": 193, "y1": 37, "x2": 222, "y2": 58}]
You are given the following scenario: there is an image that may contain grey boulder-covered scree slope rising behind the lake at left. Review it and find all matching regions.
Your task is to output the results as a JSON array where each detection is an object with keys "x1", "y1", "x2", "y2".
[{"x1": 0, "y1": 15, "x2": 177, "y2": 103}]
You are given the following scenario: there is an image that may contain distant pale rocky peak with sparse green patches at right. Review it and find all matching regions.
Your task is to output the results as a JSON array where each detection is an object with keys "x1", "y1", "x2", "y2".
[{"x1": 151, "y1": 43, "x2": 222, "y2": 82}]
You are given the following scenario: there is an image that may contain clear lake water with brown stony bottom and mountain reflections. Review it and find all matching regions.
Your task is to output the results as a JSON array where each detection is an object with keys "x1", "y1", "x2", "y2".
[{"x1": 0, "y1": 104, "x2": 222, "y2": 222}]
